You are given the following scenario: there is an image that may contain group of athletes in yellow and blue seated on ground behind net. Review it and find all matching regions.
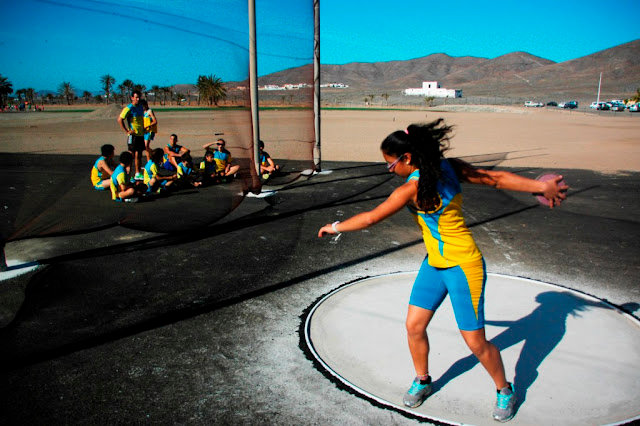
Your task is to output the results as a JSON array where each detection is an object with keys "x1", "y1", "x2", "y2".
[{"x1": 91, "y1": 134, "x2": 279, "y2": 202}]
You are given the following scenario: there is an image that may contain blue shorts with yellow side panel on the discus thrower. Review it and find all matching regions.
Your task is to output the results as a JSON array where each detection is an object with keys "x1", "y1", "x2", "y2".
[{"x1": 409, "y1": 257, "x2": 487, "y2": 331}]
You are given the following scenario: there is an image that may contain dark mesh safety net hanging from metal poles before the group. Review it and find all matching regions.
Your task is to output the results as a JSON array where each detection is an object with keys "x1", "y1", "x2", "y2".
[{"x1": 0, "y1": 0, "x2": 315, "y2": 261}]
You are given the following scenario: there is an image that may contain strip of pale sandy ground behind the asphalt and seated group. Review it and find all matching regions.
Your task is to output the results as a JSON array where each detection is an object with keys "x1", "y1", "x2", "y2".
[{"x1": 0, "y1": 105, "x2": 640, "y2": 173}]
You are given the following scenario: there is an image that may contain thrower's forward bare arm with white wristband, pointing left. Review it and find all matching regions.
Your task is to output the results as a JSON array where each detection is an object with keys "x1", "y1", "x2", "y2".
[{"x1": 318, "y1": 181, "x2": 418, "y2": 237}]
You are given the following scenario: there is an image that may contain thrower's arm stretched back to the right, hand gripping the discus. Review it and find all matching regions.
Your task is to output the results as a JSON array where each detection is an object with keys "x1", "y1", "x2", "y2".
[{"x1": 450, "y1": 158, "x2": 569, "y2": 208}]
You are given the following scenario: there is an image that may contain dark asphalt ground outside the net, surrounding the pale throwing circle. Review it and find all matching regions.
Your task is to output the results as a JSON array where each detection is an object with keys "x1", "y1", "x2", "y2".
[{"x1": 0, "y1": 158, "x2": 640, "y2": 424}]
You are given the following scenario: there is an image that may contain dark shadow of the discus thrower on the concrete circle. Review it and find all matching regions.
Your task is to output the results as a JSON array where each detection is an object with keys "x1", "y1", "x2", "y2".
[{"x1": 433, "y1": 291, "x2": 608, "y2": 409}]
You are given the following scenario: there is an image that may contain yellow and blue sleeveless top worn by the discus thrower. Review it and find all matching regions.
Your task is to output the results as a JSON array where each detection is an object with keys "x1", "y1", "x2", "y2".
[{"x1": 407, "y1": 159, "x2": 482, "y2": 268}]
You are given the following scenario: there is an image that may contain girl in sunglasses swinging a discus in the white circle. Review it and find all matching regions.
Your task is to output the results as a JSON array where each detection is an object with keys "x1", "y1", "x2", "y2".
[{"x1": 318, "y1": 119, "x2": 568, "y2": 422}]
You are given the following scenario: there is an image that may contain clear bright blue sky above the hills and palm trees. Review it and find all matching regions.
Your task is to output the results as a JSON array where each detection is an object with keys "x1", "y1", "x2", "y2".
[{"x1": 0, "y1": 0, "x2": 640, "y2": 91}]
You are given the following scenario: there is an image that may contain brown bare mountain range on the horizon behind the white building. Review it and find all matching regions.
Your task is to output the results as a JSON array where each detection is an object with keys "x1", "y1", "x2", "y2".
[{"x1": 258, "y1": 39, "x2": 640, "y2": 99}]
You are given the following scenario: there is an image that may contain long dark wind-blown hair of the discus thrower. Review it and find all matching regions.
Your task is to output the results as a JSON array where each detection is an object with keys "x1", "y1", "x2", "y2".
[{"x1": 380, "y1": 118, "x2": 453, "y2": 211}]
